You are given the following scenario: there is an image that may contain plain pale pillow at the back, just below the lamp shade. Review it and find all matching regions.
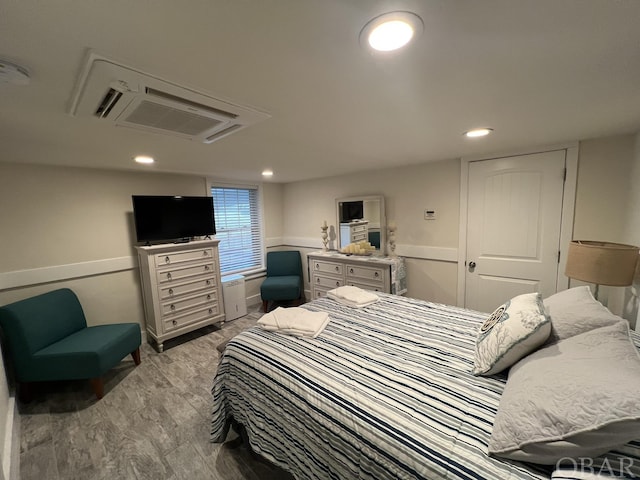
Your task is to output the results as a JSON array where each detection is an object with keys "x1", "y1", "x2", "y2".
[{"x1": 544, "y1": 285, "x2": 624, "y2": 343}]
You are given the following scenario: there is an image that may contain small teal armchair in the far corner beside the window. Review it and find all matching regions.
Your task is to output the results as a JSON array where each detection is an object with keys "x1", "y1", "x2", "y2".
[{"x1": 260, "y1": 250, "x2": 304, "y2": 312}]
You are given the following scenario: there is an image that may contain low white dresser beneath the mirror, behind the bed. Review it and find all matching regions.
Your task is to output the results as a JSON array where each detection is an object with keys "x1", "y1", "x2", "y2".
[{"x1": 307, "y1": 251, "x2": 407, "y2": 299}]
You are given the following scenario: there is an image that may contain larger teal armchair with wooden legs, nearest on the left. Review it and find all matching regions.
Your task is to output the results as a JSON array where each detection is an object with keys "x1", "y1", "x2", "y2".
[{"x1": 0, "y1": 288, "x2": 141, "y2": 401}]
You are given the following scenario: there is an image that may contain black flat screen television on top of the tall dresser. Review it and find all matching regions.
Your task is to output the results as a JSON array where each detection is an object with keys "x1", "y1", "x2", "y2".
[{"x1": 131, "y1": 195, "x2": 216, "y2": 243}]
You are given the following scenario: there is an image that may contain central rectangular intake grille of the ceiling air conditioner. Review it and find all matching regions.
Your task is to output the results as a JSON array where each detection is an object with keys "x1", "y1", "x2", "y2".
[{"x1": 125, "y1": 100, "x2": 223, "y2": 136}]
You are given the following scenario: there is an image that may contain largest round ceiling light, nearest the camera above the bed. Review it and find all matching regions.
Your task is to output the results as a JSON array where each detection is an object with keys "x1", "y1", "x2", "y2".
[{"x1": 360, "y1": 12, "x2": 424, "y2": 52}]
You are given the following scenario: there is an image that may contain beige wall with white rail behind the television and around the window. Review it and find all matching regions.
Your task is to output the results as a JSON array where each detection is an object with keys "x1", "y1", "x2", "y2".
[{"x1": 0, "y1": 163, "x2": 282, "y2": 478}]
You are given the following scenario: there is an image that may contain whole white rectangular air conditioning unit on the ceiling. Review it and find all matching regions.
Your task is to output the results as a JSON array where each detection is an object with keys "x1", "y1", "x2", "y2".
[{"x1": 69, "y1": 52, "x2": 270, "y2": 143}]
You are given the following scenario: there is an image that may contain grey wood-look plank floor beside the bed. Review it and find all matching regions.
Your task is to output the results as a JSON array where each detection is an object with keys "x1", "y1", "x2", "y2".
[{"x1": 19, "y1": 309, "x2": 292, "y2": 480}]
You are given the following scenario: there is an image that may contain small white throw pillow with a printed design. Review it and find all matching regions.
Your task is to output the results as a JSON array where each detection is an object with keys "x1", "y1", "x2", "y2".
[{"x1": 473, "y1": 293, "x2": 551, "y2": 375}]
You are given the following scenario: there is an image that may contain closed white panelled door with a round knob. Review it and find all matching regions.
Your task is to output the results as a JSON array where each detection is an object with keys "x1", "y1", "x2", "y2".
[{"x1": 465, "y1": 150, "x2": 566, "y2": 312}]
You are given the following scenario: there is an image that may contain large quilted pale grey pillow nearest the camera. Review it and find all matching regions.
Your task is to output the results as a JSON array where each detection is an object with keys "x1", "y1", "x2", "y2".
[{"x1": 489, "y1": 321, "x2": 640, "y2": 465}]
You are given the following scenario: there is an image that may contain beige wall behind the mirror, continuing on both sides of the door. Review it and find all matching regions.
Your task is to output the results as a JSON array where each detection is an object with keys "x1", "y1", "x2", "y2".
[{"x1": 283, "y1": 135, "x2": 640, "y2": 312}]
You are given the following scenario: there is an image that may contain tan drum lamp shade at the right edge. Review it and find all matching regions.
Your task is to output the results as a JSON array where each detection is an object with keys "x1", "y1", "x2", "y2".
[{"x1": 565, "y1": 240, "x2": 638, "y2": 287}]
